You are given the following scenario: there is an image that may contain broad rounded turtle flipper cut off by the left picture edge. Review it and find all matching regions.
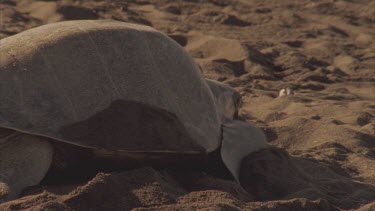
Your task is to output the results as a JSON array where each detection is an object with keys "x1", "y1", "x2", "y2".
[{"x1": 0, "y1": 129, "x2": 53, "y2": 203}]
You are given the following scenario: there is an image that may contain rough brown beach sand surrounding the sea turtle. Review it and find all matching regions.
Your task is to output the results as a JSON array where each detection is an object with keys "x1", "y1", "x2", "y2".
[{"x1": 0, "y1": 0, "x2": 375, "y2": 210}]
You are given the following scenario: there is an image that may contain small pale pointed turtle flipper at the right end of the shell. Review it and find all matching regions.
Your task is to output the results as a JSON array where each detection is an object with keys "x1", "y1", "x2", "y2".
[{"x1": 221, "y1": 120, "x2": 268, "y2": 182}]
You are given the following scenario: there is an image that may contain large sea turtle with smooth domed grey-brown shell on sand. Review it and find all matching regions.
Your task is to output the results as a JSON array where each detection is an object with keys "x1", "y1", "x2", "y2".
[{"x1": 0, "y1": 20, "x2": 267, "y2": 201}]
